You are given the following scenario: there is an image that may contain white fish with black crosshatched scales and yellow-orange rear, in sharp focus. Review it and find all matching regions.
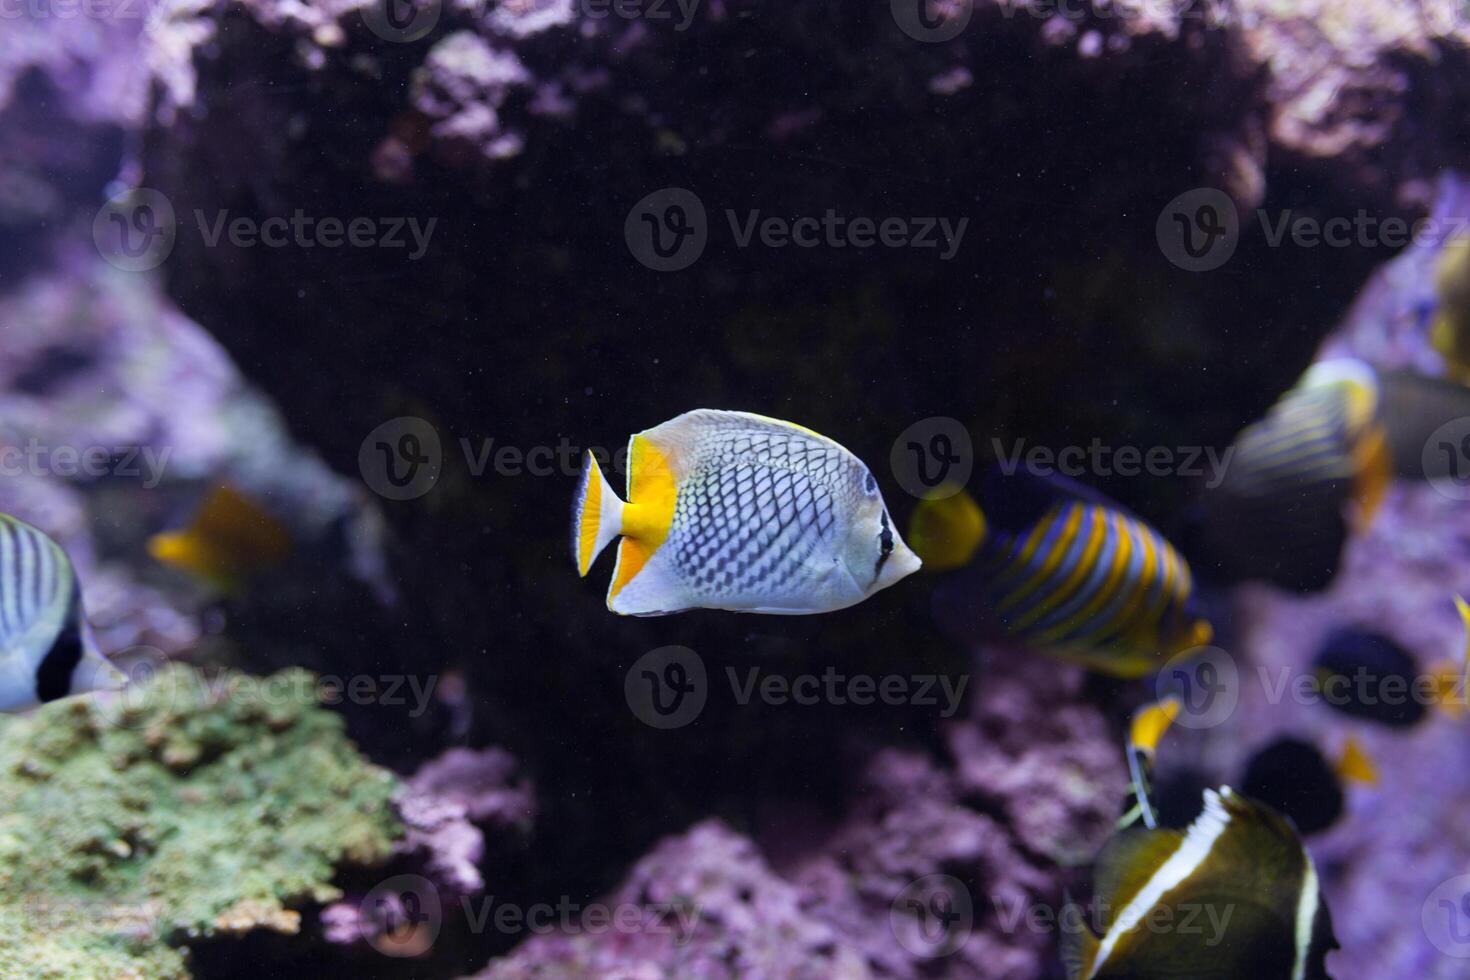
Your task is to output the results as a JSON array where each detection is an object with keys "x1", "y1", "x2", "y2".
[{"x1": 572, "y1": 408, "x2": 919, "y2": 616}]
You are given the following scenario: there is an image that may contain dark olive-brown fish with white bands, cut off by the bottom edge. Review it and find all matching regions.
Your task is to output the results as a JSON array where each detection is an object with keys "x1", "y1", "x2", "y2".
[{"x1": 1061, "y1": 786, "x2": 1338, "y2": 980}]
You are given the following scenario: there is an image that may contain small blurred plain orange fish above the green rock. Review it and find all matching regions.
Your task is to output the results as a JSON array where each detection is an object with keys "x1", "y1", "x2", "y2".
[{"x1": 148, "y1": 485, "x2": 291, "y2": 592}]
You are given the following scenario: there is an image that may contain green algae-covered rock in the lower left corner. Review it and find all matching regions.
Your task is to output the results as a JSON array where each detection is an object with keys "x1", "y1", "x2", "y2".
[{"x1": 0, "y1": 666, "x2": 401, "y2": 980}]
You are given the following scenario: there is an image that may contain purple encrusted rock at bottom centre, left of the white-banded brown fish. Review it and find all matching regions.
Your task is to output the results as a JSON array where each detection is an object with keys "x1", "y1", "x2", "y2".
[{"x1": 478, "y1": 654, "x2": 1125, "y2": 980}]
